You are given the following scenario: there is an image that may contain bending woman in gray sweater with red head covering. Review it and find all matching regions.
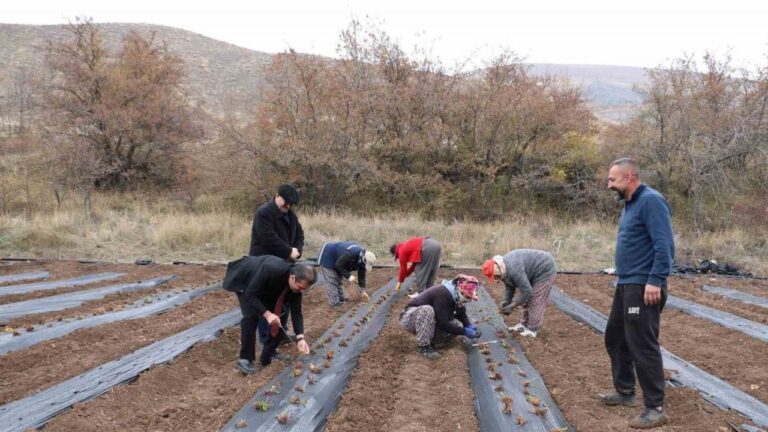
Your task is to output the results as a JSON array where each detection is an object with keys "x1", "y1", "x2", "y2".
[{"x1": 483, "y1": 249, "x2": 557, "y2": 337}]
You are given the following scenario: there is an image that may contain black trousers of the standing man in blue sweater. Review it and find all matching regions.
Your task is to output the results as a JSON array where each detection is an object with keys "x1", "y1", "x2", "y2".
[{"x1": 605, "y1": 284, "x2": 667, "y2": 407}]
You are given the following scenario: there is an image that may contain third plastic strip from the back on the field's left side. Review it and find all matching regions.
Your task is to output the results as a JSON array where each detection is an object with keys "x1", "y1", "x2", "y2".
[{"x1": 0, "y1": 276, "x2": 176, "y2": 323}]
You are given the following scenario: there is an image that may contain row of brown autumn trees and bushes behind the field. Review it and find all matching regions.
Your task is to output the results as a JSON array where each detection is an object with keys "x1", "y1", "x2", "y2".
[{"x1": 0, "y1": 20, "x2": 768, "y2": 229}]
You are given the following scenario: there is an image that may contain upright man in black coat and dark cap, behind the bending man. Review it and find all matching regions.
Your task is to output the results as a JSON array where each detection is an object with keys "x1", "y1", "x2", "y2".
[{"x1": 248, "y1": 184, "x2": 304, "y2": 260}]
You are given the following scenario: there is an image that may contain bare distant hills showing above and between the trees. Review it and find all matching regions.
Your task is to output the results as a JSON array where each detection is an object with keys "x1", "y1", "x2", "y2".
[{"x1": 0, "y1": 24, "x2": 646, "y2": 121}]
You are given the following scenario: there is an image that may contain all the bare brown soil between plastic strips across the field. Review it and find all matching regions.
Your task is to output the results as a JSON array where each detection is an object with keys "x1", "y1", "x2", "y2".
[{"x1": 0, "y1": 262, "x2": 768, "y2": 432}]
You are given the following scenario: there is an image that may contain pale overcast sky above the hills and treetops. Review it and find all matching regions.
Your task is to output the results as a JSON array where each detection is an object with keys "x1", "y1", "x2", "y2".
[{"x1": 6, "y1": 0, "x2": 768, "y2": 67}]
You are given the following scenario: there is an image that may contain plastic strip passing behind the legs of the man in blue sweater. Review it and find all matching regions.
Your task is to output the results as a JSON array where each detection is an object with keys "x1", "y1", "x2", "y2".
[{"x1": 550, "y1": 288, "x2": 768, "y2": 427}]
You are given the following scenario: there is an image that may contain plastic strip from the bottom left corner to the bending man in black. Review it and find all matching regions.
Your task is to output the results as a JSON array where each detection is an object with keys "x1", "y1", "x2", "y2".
[{"x1": 0, "y1": 308, "x2": 241, "y2": 432}]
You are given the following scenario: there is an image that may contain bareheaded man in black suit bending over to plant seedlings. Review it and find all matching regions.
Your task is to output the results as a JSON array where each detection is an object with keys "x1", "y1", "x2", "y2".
[{"x1": 223, "y1": 255, "x2": 315, "y2": 374}]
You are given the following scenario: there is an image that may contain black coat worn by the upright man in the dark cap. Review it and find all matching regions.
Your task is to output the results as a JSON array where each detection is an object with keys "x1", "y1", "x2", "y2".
[{"x1": 248, "y1": 199, "x2": 304, "y2": 259}]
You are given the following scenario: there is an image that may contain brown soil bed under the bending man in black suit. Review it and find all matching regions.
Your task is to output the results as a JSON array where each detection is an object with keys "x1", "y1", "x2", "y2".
[{"x1": 38, "y1": 271, "x2": 393, "y2": 432}]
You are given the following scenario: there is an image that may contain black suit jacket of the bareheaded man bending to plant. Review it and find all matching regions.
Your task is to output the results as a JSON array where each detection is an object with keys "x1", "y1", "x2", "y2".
[{"x1": 223, "y1": 255, "x2": 304, "y2": 334}]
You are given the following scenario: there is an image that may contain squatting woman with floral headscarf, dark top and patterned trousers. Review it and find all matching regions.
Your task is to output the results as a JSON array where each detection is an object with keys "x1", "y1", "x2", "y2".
[{"x1": 400, "y1": 274, "x2": 480, "y2": 360}]
